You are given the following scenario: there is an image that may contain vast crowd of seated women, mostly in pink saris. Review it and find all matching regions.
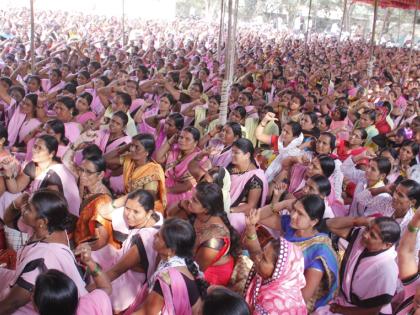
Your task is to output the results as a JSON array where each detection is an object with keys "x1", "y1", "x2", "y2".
[{"x1": 0, "y1": 2, "x2": 420, "y2": 315}]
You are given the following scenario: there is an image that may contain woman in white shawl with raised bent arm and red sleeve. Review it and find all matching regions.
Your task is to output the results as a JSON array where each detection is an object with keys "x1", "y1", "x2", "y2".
[{"x1": 256, "y1": 113, "x2": 303, "y2": 183}]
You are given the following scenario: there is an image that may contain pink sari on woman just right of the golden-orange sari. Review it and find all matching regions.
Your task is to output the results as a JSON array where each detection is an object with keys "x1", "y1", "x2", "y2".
[{"x1": 165, "y1": 146, "x2": 200, "y2": 207}]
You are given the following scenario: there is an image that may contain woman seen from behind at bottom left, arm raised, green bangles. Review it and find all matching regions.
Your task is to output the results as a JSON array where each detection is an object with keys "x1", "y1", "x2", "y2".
[{"x1": 33, "y1": 246, "x2": 112, "y2": 315}]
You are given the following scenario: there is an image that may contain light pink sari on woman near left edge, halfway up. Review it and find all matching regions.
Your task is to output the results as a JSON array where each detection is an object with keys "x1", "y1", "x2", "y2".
[{"x1": 7, "y1": 109, "x2": 41, "y2": 146}]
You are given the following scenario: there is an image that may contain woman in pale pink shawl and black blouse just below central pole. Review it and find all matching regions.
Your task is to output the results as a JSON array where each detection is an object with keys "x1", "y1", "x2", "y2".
[{"x1": 227, "y1": 138, "x2": 268, "y2": 213}]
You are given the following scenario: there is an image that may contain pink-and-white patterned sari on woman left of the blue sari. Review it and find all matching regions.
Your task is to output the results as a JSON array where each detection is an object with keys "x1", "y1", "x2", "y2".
[{"x1": 245, "y1": 238, "x2": 308, "y2": 315}]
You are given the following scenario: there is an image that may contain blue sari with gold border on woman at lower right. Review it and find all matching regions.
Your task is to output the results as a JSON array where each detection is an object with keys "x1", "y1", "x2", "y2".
[{"x1": 281, "y1": 215, "x2": 339, "y2": 312}]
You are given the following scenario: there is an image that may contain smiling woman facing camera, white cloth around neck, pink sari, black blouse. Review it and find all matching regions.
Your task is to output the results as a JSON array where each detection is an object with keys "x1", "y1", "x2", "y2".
[{"x1": 88, "y1": 189, "x2": 163, "y2": 313}]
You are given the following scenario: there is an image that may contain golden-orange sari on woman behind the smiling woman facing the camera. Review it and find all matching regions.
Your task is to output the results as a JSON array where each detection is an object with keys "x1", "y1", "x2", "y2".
[{"x1": 123, "y1": 157, "x2": 166, "y2": 213}]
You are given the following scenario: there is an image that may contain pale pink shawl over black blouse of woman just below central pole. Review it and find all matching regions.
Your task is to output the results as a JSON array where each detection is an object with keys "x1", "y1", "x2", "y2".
[{"x1": 230, "y1": 168, "x2": 268, "y2": 207}]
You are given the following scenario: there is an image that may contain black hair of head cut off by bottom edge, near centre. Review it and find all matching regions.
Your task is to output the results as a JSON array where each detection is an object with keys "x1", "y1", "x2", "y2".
[{"x1": 202, "y1": 288, "x2": 251, "y2": 315}]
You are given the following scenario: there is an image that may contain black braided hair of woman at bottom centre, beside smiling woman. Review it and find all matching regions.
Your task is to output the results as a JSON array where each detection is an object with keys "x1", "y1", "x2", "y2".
[{"x1": 160, "y1": 218, "x2": 208, "y2": 297}]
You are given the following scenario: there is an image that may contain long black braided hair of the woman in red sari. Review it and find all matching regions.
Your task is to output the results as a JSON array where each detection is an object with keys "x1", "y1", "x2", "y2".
[{"x1": 195, "y1": 183, "x2": 241, "y2": 258}]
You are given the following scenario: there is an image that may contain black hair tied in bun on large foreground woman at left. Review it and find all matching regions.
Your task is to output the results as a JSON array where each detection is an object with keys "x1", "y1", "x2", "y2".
[{"x1": 29, "y1": 189, "x2": 69, "y2": 233}]
